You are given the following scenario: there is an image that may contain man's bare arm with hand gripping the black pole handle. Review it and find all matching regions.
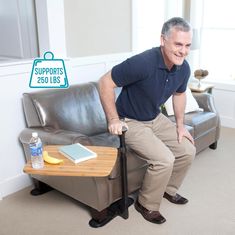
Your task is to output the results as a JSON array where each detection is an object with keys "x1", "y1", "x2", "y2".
[{"x1": 99, "y1": 71, "x2": 124, "y2": 135}]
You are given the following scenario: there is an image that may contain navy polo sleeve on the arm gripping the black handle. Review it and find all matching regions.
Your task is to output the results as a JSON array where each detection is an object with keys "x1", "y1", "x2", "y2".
[{"x1": 111, "y1": 54, "x2": 148, "y2": 87}]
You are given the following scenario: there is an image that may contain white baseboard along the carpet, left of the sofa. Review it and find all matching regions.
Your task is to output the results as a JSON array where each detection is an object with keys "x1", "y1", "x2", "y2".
[{"x1": 0, "y1": 174, "x2": 32, "y2": 200}]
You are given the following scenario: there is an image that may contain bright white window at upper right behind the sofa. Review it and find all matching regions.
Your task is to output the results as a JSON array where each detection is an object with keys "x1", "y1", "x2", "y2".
[{"x1": 199, "y1": 0, "x2": 235, "y2": 83}]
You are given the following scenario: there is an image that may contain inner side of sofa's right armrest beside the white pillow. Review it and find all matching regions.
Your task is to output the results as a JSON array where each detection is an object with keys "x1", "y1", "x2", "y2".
[{"x1": 192, "y1": 92, "x2": 218, "y2": 114}]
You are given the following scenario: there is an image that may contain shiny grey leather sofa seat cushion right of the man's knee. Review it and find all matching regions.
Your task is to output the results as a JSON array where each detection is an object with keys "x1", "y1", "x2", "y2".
[{"x1": 184, "y1": 112, "x2": 218, "y2": 139}]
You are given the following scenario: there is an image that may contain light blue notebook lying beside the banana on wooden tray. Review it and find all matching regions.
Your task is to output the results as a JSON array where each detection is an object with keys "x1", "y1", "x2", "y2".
[{"x1": 59, "y1": 143, "x2": 97, "y2": 163}]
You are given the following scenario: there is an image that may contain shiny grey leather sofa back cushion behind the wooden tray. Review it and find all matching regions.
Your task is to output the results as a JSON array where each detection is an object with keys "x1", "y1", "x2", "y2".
[{"x1": 24, "y1": 83, "x2": 107, "y2": 135}]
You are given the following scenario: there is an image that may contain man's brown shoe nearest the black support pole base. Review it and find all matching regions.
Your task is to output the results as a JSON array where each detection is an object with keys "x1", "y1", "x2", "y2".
[{"x1": 135, "y1": 199, "x2": 166, "y2": 224}]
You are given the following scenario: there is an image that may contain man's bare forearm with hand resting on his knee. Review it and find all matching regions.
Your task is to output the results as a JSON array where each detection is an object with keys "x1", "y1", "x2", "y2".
[{"x1": 172, "y1": 92, "x2": 194, "y2": 144}]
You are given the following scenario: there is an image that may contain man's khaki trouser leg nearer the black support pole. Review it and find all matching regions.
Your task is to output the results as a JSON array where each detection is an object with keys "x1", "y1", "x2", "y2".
[{"x1": 125, "y1": 119, "x2": 175, "y2": 211}]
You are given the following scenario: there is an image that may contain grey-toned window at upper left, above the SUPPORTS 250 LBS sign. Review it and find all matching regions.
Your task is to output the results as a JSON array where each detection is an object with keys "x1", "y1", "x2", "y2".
[{"x1": 0, "y1": 0, "x2": 38, "y2": 62}]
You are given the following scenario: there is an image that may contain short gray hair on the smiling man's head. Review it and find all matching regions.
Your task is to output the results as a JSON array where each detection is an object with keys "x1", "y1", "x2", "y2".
[{"x1": 161, "y1": 17, "x2": 191, "y2": 36}]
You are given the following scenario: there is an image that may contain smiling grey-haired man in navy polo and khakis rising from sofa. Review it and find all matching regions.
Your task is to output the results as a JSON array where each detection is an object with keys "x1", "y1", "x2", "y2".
[{"x1": 99, "y1": 17, "x2": 195, "y2": 224}]
